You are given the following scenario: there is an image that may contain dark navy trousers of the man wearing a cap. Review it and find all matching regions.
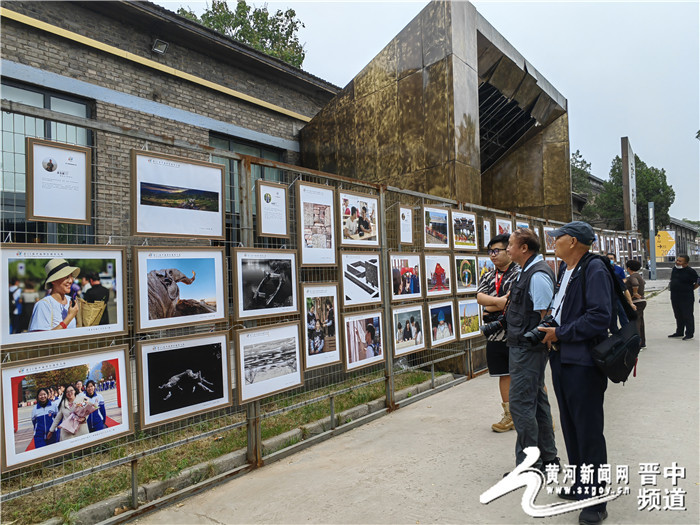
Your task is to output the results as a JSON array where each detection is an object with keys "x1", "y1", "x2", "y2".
[{"x1": 549, "y1": 351, "x2": 608, "y2": 511}]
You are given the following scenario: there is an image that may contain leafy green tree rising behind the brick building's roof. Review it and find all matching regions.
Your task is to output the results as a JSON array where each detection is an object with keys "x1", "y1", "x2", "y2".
[{"x1": 177, "y1": 0, "x2": 306, "y2": 67}]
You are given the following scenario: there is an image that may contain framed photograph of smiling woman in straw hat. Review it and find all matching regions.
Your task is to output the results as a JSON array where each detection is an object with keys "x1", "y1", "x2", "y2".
[{"x1": 0, "y1": 243, "x2": 127, "y2": 348}]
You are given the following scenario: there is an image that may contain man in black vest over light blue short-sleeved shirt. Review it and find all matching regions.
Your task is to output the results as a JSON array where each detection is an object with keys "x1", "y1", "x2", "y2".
[{"x1": 506, "y1": 228, "x2": 559, "y2": 472}]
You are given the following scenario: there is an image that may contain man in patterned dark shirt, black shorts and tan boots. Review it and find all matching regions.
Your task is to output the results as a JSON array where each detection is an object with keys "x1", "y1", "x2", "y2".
[{"x1": 476, "y1": 233, "x2": 520, "y2": 432}]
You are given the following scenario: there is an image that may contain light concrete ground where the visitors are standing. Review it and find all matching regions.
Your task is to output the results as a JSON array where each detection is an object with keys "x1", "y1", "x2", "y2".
[{"x1": 136, "y1": 283, "x2": 700, "y2": 525}]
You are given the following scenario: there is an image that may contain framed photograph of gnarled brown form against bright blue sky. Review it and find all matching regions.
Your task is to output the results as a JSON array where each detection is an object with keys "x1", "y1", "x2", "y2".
[{"x1": 134, "y1": 247, "x2": 228, "y2": 330}]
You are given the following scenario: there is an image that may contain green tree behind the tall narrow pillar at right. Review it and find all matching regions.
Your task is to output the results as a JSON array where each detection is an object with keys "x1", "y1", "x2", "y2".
[{"x1": 588, "y1": 155, "x2": 676, "y2": 239}]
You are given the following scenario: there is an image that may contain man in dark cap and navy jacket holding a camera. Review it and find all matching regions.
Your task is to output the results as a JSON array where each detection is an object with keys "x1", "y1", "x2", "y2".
[{"x1": 539, "y1": 221, "x2": 613, "y2": 525}]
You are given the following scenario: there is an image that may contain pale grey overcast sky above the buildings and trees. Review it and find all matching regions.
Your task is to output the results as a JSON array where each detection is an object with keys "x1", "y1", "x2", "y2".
[{"x1": 157, "y1": 0, "x2": 700, "y2": 220}]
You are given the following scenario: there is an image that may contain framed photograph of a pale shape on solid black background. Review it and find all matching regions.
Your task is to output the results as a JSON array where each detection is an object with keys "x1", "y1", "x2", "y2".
[{"x1": 136, "y1": 332, "x2": 233, "y2": 428}]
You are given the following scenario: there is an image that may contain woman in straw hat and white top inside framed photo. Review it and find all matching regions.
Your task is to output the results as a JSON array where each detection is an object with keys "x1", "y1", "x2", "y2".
[{"x1": 29, "y1": 259, "x2": 80, "y2": 332}]
